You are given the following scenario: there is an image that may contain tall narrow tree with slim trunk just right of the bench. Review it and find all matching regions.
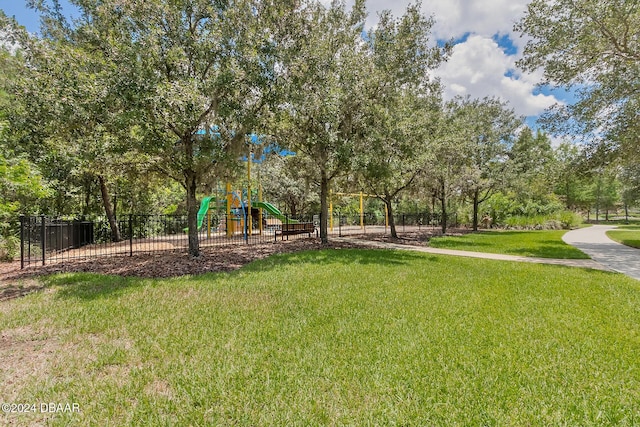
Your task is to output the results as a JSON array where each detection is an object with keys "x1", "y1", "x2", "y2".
[{"x1": 278, "y1": 0, "x2": 369, "y2": 243}]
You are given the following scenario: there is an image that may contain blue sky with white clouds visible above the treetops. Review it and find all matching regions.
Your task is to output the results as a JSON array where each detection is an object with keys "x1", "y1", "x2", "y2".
[{"x1": 0, "y1": 0, "x2": 572, "y2": 133}]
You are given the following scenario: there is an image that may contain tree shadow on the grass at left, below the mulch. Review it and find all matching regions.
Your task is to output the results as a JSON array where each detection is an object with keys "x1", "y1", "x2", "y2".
[{"x1": 43, "y1": 273, "x2": 144, "y2": 300}]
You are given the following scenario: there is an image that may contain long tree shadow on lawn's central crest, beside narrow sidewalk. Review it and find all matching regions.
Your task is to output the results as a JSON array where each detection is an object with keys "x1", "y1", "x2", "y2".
[{"x1": 242, "y1": 248, "x2": 439, "y2": 271}]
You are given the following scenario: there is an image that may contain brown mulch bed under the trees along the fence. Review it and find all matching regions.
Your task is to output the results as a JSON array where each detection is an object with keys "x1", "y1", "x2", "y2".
[{"x1": 0, "y1": 239, "x2": 366, "y2": 301}]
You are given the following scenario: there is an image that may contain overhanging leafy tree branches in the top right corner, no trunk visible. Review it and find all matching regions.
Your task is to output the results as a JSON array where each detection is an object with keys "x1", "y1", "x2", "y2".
[{"x1": 515, "y1": 0, "x2": 640, "y2": 162}]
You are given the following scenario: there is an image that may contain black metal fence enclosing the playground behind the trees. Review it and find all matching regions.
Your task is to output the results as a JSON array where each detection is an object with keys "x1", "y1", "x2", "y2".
[{"x1": 20, "y1": 213, "x2": 457, "y2": 268}]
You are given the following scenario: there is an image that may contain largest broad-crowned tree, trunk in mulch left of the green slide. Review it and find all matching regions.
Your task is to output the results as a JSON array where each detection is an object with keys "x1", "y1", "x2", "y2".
[{"x1": 6, "y1": 0, "x2": 295, "y2": 257}]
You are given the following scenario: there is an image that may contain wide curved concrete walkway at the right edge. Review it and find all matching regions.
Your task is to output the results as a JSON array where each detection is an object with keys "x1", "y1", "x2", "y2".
[{"x1": 562, "y1": 225, "x2": 640, "y2": 280}]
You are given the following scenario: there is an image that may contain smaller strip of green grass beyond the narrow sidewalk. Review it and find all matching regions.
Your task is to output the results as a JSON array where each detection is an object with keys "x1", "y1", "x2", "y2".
[{"x1": 429, "y1": 230, "x2": 589, "y2": 259}]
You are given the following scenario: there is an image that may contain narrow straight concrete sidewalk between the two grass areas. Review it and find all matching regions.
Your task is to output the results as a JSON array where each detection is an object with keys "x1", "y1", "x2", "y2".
[{"x1": 335, "y1": 237, "x2": 611, "y2": 270}]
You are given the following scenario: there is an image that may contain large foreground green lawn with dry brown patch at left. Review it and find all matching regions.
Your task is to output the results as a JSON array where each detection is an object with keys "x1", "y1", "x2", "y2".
[{"x1": 0, "y1": 250, "x2": 640, "y2": 426}]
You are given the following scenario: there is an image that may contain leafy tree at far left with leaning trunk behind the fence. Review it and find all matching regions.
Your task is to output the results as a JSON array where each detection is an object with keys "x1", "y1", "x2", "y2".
[{"x1": 2, "y1": 8, "x2": 156, "y2": 242}]
